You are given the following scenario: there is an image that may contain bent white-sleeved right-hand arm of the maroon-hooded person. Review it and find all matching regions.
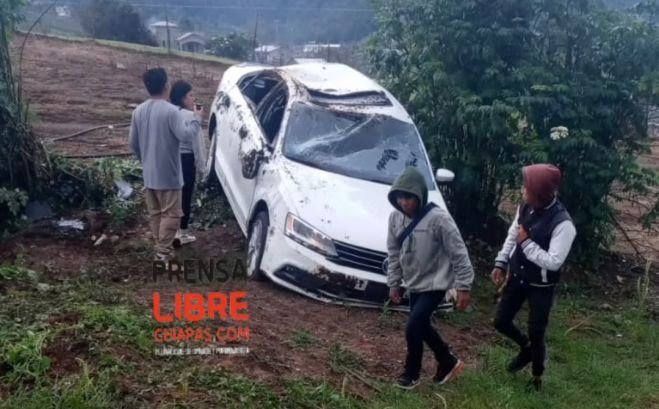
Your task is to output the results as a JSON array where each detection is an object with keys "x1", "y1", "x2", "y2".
[{"x1": 522, "y1": 220, "x2": 577, "y2": 271}]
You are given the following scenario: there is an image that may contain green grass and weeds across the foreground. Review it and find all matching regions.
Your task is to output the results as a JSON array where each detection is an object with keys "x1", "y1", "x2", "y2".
[{"x1": 0, "y1": 252, "x2": 659, "y2": 409}]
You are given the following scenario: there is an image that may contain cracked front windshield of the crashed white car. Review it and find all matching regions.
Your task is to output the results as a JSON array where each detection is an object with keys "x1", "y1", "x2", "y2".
[{"x1": 283, "y1": 102, "x2": 434, "y2": 189}]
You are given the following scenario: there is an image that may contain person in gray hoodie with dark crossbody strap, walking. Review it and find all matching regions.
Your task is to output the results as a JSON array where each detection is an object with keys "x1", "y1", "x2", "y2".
[{"x1": 387, "y1": 167, "x2": 474, "y2": 389}]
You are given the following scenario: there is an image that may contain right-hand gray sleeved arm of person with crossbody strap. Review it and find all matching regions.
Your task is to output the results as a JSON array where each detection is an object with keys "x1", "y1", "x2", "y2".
[{"x1": 433, "y1": 210, "x2": 474, "y2": 291}]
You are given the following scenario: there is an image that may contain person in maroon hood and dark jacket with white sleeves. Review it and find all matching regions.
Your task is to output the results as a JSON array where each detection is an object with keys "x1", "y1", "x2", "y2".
[{"x1": 492, "y1": 164, "x2": 577, "y2": 390}]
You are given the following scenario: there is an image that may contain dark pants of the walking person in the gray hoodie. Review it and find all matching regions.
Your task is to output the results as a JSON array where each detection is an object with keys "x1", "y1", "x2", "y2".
[{"x1": 405, "y1": 291, "x2": 455, "y2": 379}]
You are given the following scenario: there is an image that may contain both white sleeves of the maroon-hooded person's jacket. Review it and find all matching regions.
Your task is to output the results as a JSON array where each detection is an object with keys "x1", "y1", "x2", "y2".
[{"x1": 495, "y1": 200, "x2": 577, "y2": 278}]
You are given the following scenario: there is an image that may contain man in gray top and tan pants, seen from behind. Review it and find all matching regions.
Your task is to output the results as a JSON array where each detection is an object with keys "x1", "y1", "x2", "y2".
[{"x1": 129, "y1": 68, "x2": 202, "y2": 261}]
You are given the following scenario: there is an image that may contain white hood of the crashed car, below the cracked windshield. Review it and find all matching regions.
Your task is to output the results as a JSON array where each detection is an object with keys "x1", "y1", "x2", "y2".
[{"x1": 281, "y1": 160, "x2": 444, "y2": 252}]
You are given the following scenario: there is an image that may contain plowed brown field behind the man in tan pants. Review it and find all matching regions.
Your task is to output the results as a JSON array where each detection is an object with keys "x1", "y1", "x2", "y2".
[{"x1": 15, "y1": 36, "x2": 225, "y2": 155}]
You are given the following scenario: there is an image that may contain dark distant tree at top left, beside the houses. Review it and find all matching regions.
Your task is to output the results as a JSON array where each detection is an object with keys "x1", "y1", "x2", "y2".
[{"x1": 79, "y1": 0, "x2": 158, "y2": 46}]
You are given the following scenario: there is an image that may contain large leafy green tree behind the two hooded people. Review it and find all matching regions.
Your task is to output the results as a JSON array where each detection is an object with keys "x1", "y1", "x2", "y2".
[{"x1": 370, "y1": 0, "x2": 659, "y2": 258}]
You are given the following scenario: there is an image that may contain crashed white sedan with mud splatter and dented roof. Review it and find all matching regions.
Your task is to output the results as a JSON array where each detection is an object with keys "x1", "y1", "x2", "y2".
[{"x1": 206, "y1": 63, "x2": 453, "y2": 310}]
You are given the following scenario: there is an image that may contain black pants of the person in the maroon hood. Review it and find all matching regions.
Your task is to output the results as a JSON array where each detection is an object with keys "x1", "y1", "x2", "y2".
[{"x1": 494, "y1": 275, "x2": 555, "y2": 376}]
